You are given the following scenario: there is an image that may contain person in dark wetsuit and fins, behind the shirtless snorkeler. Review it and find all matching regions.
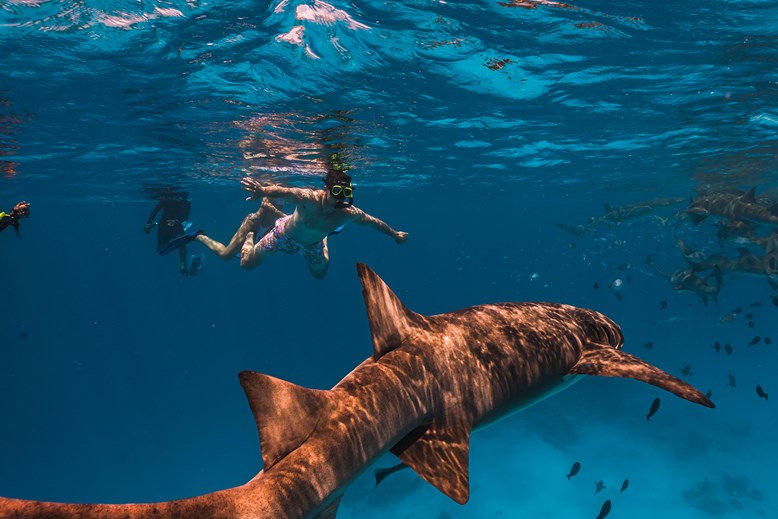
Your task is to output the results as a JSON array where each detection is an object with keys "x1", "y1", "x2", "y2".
[{"x1": 143, "y1": 190, "x2": 203, "y2": 276}]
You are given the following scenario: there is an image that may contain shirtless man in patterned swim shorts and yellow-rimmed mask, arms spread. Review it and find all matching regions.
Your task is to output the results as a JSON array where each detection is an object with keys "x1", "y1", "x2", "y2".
[{"x1": 235, "y1": 169, "x2": 408, "y2": 279}]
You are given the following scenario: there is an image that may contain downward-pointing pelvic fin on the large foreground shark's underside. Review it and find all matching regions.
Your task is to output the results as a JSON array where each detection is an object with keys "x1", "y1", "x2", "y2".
[{"x1": 391, "y1": 421, "x2": 471, "y2": 505}]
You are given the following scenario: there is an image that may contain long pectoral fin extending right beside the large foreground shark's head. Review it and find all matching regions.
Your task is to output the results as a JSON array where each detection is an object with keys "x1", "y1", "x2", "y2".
[{"x1": 570, "y1": 344, "x2": 716, "y2": 407}]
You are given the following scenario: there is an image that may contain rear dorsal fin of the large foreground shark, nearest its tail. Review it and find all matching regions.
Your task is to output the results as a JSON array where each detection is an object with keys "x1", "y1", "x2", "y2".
[{"x1": 239, "y1": 371, "x2": 329, "y2": 470}]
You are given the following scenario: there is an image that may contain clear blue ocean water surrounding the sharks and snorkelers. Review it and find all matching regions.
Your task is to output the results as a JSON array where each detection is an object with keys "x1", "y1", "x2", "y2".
[{"x1": 0, "y1": 0, "x2": 778, "y2": 519}]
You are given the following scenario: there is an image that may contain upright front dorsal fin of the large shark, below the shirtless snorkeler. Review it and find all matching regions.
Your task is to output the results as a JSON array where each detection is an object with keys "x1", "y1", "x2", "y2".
[{"x1": 357, "y1": 263, "x2": 425, "y2": 360}]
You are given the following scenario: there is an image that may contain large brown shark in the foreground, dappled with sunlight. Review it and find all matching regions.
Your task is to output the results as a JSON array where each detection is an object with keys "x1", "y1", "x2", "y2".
[{"x1": 0, "y1": 264, "x2": 713, "y2": 519}]
